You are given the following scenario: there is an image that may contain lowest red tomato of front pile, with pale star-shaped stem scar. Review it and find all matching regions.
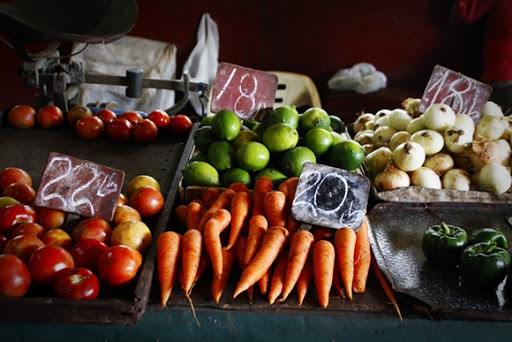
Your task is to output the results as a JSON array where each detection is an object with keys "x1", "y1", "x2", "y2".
[{"x1": 53, "y1": 267, "x2": 100, "y2": 299}]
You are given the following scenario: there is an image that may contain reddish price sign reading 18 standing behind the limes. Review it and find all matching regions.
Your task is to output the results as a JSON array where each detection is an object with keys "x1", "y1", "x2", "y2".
[{"x1": 210, "y1": 63, "x2": 277, "y2": 120}]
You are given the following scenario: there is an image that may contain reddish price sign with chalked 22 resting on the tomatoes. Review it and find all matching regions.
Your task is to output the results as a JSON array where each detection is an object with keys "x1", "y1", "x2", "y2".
[{"x1": 34, "y1": 152, "x2": 124, "y2": 221}]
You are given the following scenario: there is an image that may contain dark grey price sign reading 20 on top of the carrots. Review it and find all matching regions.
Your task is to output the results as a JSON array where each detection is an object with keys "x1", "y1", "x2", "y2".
[{"x1": 291, "y1": 163, "x2": 370, "y2": 231}]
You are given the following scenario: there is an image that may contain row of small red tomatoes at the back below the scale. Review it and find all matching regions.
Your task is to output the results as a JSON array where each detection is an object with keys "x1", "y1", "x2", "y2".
[{"x1": 8, "y1": 105, "x2": 193, "y2": 143}]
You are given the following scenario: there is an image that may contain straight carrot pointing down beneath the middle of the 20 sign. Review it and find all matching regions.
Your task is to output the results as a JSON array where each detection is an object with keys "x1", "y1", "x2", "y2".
[{"x1": 313, "y1": 240, "x2": 335, "y2": 309}]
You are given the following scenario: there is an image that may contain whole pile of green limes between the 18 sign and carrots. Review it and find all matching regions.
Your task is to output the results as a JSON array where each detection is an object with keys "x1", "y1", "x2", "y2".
[{"x1": 182, "y1": 105, "x2": 364, "y2": 188}]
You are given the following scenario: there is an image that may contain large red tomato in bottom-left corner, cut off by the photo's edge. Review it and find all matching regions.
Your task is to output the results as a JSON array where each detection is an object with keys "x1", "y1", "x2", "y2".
[{"x1": 0, "y1": 254, "x2": 30, "y2": 297}]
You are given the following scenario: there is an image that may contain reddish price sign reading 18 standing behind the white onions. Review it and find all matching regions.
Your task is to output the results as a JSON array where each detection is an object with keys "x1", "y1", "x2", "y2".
[{"x1": 420, "y1": 65, "x2": 492, "y2": 123}]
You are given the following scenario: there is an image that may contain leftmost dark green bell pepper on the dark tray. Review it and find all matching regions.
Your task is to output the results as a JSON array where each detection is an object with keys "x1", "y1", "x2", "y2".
[{"x1": 421, "y1": 222, "x2": 468, "y2": 267}]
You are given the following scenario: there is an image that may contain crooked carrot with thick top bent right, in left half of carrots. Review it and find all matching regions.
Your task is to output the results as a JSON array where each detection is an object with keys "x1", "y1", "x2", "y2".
[{"x1": 204, "y1": 209, "x2": 231, "y2": 278}]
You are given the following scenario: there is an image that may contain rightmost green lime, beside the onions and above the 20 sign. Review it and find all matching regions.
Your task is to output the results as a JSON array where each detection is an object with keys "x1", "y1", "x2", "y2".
[{"x1": 326, "y1": 140, "x2": 364, "y2": 170}]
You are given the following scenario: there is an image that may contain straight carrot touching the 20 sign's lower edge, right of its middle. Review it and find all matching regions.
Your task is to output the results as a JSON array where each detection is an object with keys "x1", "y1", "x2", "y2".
[{"x1": 334, "y1": 227, "x2": 356, "y2": 300}]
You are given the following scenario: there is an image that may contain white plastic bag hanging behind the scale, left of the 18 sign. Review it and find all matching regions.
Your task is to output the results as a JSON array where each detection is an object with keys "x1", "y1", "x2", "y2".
[{"x1": 183, "y1": 13, "x2": 219, "y2": 115}]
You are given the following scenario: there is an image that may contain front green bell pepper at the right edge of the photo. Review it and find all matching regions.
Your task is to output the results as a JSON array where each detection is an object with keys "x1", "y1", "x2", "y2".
[{"x1": 460, "y1": 242, "x2": 511, "y2": 288}]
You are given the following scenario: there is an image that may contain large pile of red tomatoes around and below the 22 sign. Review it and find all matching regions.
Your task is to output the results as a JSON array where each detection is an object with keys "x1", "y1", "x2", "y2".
[{"x1": 0, "y1": 167, "x2": 164, "y2": 299}]
